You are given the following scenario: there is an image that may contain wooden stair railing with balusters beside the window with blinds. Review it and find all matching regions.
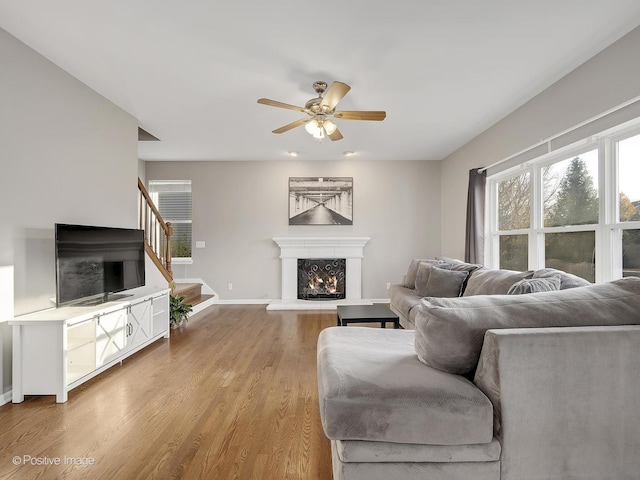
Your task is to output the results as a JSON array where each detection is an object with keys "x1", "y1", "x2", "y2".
[{"x1": 138, "y1": 178, "x2": 173, "y2": 286}]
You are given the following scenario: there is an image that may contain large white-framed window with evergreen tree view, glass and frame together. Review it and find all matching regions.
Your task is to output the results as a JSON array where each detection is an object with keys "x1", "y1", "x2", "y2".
[{"x1": 486, "y1": 124, "x2": 640, "y2": 282}]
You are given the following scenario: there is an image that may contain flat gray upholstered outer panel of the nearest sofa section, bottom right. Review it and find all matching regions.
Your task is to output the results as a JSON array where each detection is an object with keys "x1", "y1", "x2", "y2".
[{"x1": 474, "y1": 326, "x2": 640, "y2": 480}]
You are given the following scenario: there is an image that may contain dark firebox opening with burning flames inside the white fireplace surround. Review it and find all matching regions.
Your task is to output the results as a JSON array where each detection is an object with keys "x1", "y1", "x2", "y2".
[{"x1": 298, "y1": 258, "x2": 347, "y2": 300}]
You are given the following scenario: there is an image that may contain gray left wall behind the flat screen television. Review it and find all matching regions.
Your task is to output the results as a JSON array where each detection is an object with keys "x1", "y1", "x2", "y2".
[{"x1": 0, "y1": 29, "x2": 138, "y2": 393}]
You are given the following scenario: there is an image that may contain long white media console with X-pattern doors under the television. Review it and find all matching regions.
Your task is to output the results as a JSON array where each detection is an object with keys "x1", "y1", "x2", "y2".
[{"x1": 9, "y1": 287, "x2": 169, "y2": 403}]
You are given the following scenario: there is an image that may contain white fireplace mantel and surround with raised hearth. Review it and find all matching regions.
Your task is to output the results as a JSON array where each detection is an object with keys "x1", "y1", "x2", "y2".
[{"x1": 268, "y1": 237, "x2": 370, "y2": 310}]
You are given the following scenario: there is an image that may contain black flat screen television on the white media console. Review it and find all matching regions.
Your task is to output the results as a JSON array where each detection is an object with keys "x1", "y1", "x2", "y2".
[{"x1": 55, "y1": 223, "x2": 145, "y2": 306}]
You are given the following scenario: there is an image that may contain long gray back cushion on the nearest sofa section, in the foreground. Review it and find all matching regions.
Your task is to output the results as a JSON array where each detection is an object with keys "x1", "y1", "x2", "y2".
[{"x1": 415, "y1": 277, "x2": 640, "y2": 375}]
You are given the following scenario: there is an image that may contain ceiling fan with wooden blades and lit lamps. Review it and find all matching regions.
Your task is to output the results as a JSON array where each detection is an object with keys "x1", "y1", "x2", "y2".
[{"x1": 258, "y1": 81, "x2": 387, "y2": 141}]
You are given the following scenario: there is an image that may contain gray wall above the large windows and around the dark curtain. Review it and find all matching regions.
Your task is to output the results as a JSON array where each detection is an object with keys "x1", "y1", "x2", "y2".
[{"x1": 442, "y1": 24, "x2": 640, "y2": 258}]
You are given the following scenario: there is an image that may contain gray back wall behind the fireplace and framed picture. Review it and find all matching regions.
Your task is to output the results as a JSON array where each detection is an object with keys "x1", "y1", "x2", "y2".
[{"x1": 146, "y1": 160, "x2": 440, "y2": 300}]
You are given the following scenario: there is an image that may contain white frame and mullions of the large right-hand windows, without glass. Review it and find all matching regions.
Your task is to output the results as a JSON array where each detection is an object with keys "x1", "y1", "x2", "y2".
[{"x1": 485, "y1": 118, "x2": 640, "y2": 283}]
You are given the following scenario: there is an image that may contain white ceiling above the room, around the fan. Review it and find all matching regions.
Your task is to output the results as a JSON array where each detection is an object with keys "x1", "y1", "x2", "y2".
[{"x1": 0, "y1": 0, "x2": 640, "y2": 160}]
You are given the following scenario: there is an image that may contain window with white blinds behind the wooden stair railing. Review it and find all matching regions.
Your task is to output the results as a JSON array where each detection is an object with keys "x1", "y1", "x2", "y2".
[{"x1": 149, "y1": 180, "x2": 192, "y2": 259}]
